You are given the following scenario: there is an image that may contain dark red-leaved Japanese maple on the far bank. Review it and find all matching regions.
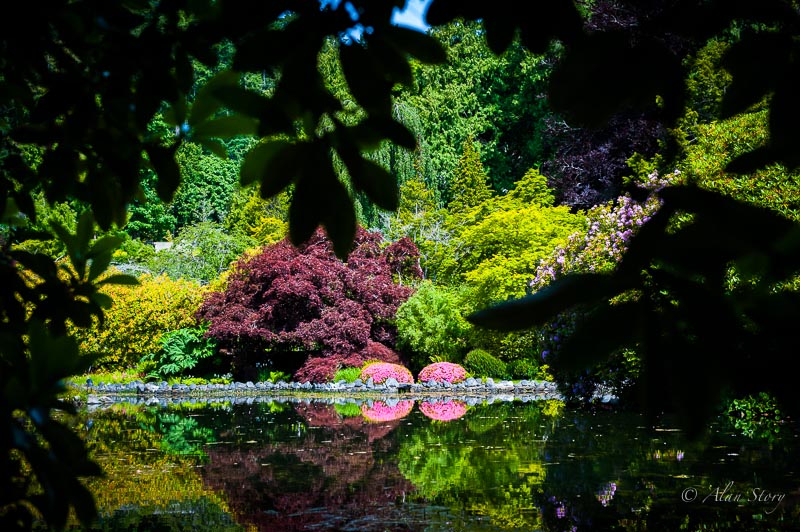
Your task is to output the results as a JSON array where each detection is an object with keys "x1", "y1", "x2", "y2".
[{"x1": 197, "y1": 228, "x2": 418, "y2": 382}]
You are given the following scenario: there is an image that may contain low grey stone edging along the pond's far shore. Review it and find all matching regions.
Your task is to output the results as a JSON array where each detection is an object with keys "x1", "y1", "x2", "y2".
[{"x1": 72, "y1": 378, "x2": 616, "y2": 405}]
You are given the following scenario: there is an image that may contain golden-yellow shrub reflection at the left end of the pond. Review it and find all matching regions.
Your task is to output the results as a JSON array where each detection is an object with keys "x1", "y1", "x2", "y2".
[{"x1": 73, "y1": 404, "x2": 237, "y2": 530}]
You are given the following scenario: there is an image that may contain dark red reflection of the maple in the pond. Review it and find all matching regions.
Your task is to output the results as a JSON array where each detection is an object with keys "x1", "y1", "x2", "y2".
[{"x1": 202, "y1": 403, "x2": 413, "y2": 532}]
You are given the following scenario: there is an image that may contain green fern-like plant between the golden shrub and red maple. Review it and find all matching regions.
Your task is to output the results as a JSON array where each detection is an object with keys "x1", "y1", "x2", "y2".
[{"x1": 142, "y1": 327, "x2": 224, "y2": 380}]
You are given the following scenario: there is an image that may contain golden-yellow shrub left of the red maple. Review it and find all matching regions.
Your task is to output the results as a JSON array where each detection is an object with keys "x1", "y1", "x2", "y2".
[{"x1": 73, "y1": 275, "x2": 207, "y2": 369}]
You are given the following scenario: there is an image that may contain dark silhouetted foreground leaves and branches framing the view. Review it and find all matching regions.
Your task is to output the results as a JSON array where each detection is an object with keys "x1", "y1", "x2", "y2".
[{"x1": 0, "y1": 0, "x2": 800, "y2": 528}]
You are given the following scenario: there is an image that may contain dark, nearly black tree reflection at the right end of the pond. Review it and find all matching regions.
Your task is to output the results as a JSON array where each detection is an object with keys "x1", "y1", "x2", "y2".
[{"x1": 539, "y1": 411, "x2": 800, "y2": 532}]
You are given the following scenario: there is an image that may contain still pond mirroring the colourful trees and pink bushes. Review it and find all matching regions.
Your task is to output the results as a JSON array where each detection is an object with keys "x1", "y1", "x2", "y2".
[{"x1": 64, "y1": 397, "x2": 800, "y2": 532}]
